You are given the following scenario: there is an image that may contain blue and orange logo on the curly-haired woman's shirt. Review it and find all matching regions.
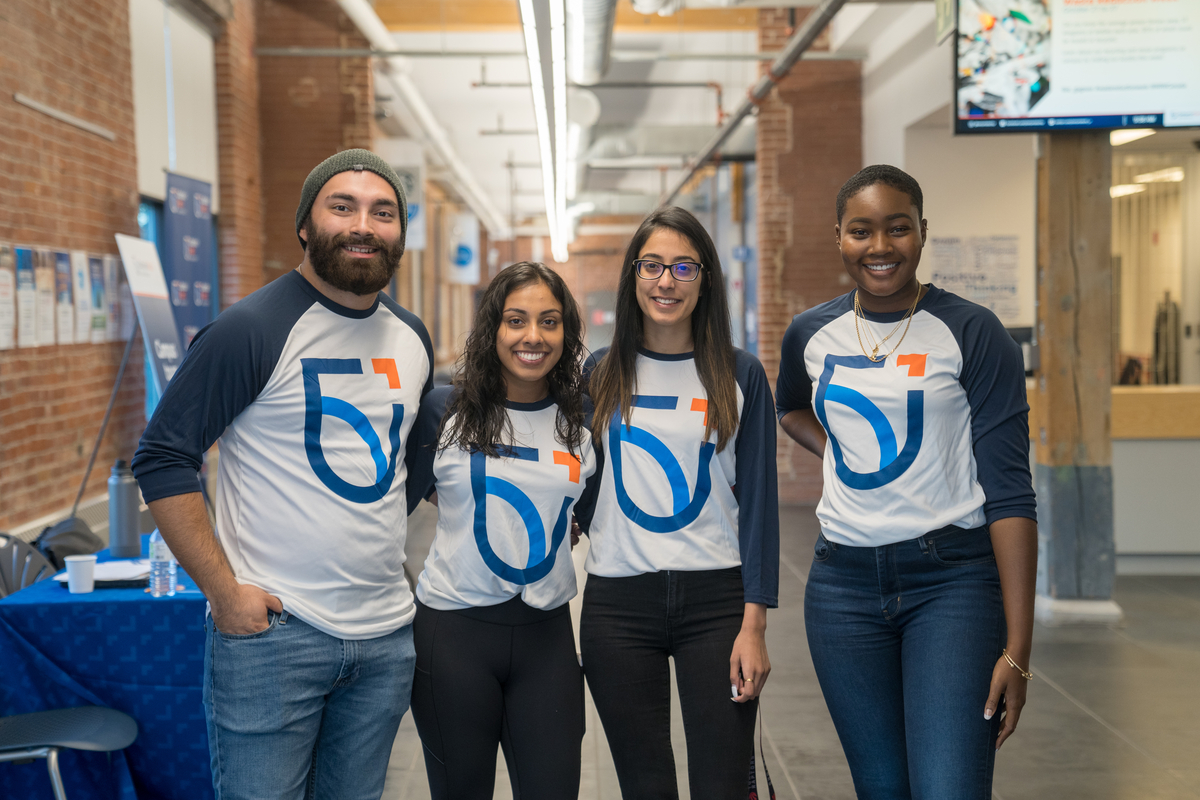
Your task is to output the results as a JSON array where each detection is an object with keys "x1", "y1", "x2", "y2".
[{"x1": 470, "y1": 445, "x2": 580, "y2": 584}]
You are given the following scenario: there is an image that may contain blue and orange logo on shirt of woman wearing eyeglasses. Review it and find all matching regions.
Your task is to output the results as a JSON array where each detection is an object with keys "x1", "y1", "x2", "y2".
[{"x1": 608, "y1": 395, "x2": 716, "y2": 534}]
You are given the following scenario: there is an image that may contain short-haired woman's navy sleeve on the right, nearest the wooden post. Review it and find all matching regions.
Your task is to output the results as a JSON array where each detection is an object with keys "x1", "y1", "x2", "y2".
[{"x1": 952, "y1": 303, "x2": 1037, "y2": 525}]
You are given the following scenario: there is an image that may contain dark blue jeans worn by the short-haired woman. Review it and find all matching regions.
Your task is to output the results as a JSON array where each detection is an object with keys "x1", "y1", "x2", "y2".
[{"x1": 804, "y1": 528, "x2": 1007, "y2": 800}]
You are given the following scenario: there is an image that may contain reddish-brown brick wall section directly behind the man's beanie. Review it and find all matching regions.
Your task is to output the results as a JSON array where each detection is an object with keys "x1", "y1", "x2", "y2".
[{"x1": 256, "y1": 0, "x2": 374, "y2": 281}]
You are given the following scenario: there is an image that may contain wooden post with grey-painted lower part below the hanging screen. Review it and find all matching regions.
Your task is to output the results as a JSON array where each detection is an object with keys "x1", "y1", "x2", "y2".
[{"x1": 1031, "y1": 131, "x2": 1121, "y2": 625}]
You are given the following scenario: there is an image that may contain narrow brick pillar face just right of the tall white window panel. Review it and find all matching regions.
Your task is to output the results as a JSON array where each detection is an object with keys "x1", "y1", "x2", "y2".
[{"x1": 214, "y1": 0, "x2": 263, "y2": 308}]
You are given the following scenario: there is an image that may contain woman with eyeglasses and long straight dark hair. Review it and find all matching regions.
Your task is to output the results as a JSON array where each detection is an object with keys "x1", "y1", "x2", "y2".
[{"x1": 576, "y1": 207, "x2": 779, "y2": 800}]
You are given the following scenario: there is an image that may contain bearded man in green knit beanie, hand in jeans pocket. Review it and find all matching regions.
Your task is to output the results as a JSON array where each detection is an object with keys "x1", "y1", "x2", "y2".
[{"x1": 133, "y1": 150, "x2": 433, "y2": 800}]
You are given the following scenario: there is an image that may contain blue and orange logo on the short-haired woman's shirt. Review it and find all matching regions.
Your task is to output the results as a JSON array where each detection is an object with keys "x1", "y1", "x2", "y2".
[{"x1": 812, "y1": 353, "x2": 928, "y2": 489}]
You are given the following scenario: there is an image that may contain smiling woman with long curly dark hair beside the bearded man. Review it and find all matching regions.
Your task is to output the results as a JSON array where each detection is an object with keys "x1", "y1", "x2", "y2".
[{"x1": 408, "y1": 261, "x2": 595, "y2": 800}]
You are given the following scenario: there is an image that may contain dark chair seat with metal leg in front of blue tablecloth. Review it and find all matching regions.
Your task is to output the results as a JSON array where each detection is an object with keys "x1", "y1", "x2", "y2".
[{"x1": 0, "y1": 705, "x2": 138, "y2": 800}]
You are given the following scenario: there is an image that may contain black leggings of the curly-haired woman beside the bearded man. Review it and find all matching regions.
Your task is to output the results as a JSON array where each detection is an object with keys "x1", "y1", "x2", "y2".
[{"x1": 412, "y1": 597, "x2": 583, "y2": 800}]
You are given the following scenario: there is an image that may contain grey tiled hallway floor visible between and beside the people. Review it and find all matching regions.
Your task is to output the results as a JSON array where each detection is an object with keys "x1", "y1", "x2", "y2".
[{"x1": 384, "y1": 504, "x2": 1200, "y2": 800}]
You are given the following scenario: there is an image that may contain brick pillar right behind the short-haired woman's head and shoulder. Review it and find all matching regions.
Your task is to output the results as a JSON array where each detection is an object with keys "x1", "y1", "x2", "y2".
[{"x1": 757, "y1": 8, "x2": 863, "y2": 503}]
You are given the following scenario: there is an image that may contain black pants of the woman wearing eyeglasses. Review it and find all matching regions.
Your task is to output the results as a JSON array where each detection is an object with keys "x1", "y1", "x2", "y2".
[{"x1": 580, "y1": 567, "x2": 758, "y2": 800}]
